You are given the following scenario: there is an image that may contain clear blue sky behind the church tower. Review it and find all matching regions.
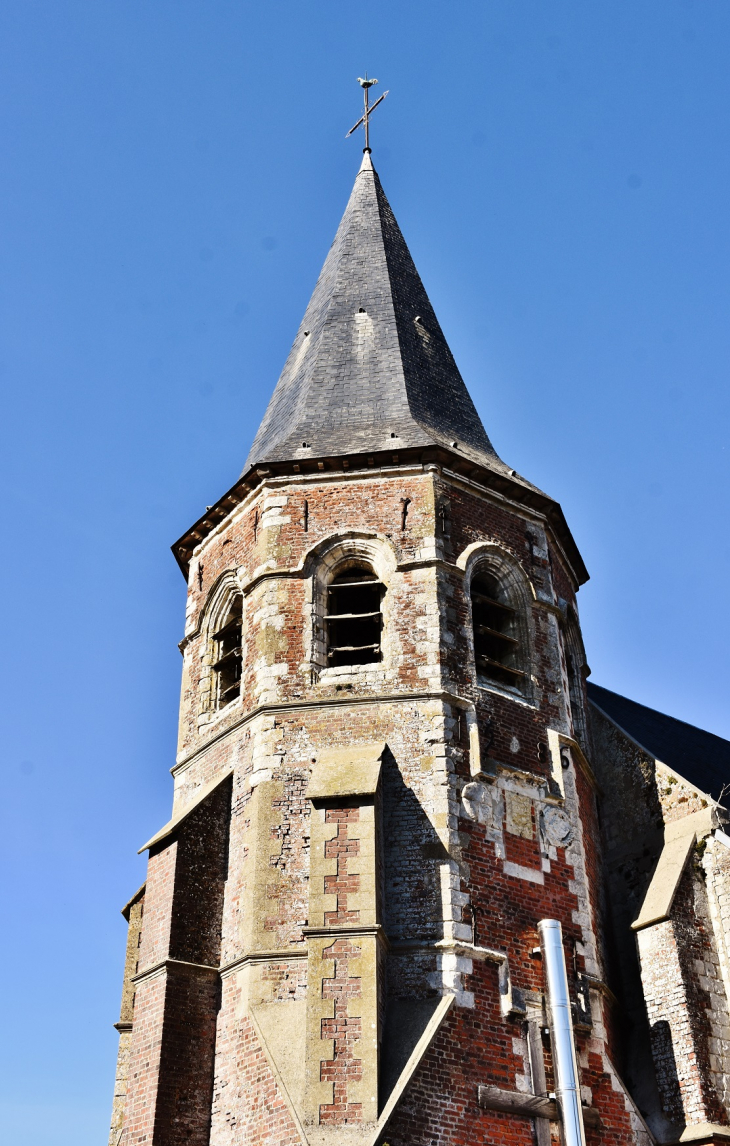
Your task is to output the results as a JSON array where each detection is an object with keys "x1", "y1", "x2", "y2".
[{"x1": 0, "y1": 0, "x2": 730, "y2": 1146}]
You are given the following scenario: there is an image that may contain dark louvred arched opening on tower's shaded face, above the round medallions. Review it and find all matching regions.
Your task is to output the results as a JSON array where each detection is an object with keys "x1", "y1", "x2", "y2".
[{"x1": 471, "y1": 572, "x2": 526, "y2": 691}]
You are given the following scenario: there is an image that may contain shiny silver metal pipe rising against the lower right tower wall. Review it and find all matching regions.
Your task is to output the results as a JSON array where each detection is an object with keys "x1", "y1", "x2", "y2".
[{"x1": 537, "y1": 919, "x2": 586, "y2": 1146}]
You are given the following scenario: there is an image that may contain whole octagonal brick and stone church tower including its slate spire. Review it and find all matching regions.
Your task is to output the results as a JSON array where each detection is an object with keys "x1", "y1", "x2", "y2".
[{"x1": 106, "y1": 150, "x2": 651, "y2": 1146}]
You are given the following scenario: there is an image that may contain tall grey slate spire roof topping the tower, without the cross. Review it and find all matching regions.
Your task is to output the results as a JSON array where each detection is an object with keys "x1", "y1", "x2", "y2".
[{"x1": 244, "y1": 151, "x2": 513, "y2": 474}]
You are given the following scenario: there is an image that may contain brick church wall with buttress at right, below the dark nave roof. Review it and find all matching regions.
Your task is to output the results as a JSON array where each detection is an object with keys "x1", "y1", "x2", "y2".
[{"x1": 591, "y1": 706, "x2": 730, "y2": 1141}]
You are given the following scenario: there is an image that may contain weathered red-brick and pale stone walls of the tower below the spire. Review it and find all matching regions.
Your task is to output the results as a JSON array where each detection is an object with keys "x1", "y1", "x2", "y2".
[{"x1": 106, "y1": 466, "x2": 641, "y2": 1146}]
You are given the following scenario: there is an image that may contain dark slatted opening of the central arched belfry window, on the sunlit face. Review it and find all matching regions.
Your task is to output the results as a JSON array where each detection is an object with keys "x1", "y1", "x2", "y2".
[{"x1": 324, "y1": 564, "x2": 385, "y2": 667}]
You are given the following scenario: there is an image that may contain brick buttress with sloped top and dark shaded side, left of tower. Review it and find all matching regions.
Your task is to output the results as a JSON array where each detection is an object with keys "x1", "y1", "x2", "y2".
[{"x1": 119, "y1": 782, "x2": 231, "y2": 1146}]
